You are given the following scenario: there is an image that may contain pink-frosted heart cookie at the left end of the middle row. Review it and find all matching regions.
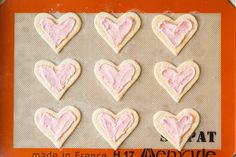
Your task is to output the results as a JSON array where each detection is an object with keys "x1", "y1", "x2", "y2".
[{"x1": 34, "y1": 58, "x2": 81, "y2": 100}]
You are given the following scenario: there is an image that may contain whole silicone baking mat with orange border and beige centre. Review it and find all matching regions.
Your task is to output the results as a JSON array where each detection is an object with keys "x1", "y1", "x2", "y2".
[{"x1": 0, "y1": 1, "x2": 235, "y2": 157}]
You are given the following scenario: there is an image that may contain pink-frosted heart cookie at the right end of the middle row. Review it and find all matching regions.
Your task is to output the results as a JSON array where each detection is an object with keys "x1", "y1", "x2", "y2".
[{"x1": 154, "y1": 61, "x2": 200, "y2": 102}]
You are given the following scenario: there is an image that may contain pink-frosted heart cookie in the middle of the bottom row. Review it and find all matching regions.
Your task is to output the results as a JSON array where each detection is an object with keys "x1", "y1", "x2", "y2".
[{"x1": 93, "y1": 108, "x2": 139, "y2": 150}]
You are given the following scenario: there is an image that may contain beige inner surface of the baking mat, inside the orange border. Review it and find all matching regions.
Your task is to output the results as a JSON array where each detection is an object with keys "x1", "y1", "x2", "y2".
[{"x1": 14, "y1": 14, "x2": 221, "y2": 148}]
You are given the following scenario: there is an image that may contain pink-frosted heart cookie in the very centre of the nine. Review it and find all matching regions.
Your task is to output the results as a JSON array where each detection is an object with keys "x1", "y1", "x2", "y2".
[{"x1": 94, "y1": 59, "x2": 141, "y2": 101}]
